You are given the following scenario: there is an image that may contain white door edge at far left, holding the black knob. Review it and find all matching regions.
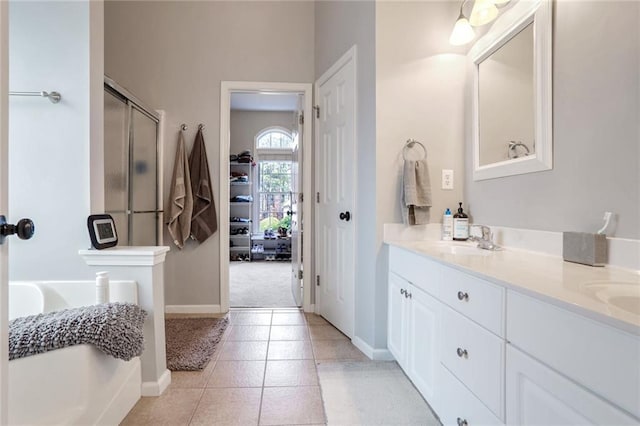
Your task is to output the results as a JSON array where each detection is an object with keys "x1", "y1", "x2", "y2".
[{"x1": 0, "y1": 2, "x2": 9, "y2": 425}]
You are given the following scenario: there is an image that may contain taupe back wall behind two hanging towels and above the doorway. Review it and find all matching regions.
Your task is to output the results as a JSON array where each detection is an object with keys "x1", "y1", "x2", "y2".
[{"x1": 105, "y1": 1, "x2": 314, "y2": 305}]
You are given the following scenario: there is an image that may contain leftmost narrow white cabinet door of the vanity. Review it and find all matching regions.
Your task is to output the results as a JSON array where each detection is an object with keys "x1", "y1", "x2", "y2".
[{"x1": 387, "y1": 273, "x2": 409, "y2": 371}]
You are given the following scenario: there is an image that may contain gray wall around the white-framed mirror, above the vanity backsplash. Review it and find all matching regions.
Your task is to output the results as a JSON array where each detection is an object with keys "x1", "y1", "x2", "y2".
[{"x1": 465, "y1": 1, "x2": 640, "y2": 239}]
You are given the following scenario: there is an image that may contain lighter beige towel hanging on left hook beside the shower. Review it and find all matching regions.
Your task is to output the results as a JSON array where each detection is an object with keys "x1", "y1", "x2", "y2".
[{"x1": 167, "y1": 132, "x2": 193, "y2": 249}]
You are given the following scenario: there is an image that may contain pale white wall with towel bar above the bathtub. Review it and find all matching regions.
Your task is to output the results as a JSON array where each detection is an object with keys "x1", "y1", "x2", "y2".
[{"x1": 9, "y1": 1, "x2": 102, "y2": 279}]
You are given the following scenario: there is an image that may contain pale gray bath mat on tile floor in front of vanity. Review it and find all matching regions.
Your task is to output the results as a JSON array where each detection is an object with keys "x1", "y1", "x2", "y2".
[{"x1": 317, "y1": 361, "x2": 440, "y2": 426}]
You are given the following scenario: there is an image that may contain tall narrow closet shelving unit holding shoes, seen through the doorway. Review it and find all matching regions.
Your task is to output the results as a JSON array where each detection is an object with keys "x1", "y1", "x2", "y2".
[{"x1": 229, "y1": 161, "x2": 253, "y2": 260}]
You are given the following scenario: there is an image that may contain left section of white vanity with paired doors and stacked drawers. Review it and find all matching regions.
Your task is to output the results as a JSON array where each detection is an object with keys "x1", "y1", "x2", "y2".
[{"x1": 387, "y1": 247, "x2": 504, "y2": 425}]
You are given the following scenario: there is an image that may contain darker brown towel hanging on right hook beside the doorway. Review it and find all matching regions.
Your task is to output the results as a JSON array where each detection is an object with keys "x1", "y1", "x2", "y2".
[{"x1": 189, "y1": 128, "x2": 218, "y2": 243}]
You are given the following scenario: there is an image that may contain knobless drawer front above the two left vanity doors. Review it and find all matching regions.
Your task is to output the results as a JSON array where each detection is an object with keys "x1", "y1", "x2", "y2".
[{"x1": 389, "y1": 246, "x2": 442, "y2": 297}]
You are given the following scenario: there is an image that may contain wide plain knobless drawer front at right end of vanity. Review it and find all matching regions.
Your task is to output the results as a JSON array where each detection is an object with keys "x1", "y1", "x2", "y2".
[{"x1": 507, "y1": 290, "x2": 640, "y2": 417}]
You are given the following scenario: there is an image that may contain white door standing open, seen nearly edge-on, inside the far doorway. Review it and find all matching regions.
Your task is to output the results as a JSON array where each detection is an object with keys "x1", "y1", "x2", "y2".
[{"x1": 287, "y1": 101, "x2": 303, "y2": 306}]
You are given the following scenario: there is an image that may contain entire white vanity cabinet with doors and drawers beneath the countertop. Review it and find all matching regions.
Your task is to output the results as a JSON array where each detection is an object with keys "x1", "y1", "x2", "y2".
[{"x1": 388, "y1": 245, "x2": 640, "y2": 426}]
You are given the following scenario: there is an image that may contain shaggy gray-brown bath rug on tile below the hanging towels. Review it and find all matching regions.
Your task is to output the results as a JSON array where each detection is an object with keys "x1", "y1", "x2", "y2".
[{"x1": 165, "y1": 318, "x2": 229, "y2": 371}]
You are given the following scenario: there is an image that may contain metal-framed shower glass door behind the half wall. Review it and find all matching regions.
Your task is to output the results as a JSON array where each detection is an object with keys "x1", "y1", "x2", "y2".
[{"x1": 104, "y1": 78, "x2": 162, "y2": 246}]
